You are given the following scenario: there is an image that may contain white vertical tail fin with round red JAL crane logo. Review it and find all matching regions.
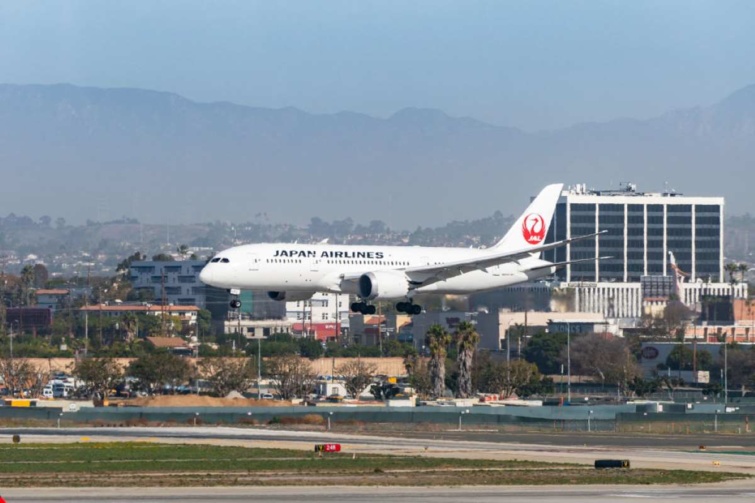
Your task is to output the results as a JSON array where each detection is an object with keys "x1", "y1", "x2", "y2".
[{"x1": 494, "y1": 183, "x2": 564, "y2": 255}]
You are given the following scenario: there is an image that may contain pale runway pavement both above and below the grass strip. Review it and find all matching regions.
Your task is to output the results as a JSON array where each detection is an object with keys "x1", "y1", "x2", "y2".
[{"x1": 0, "y1": 426, "x2": 755, "y2": 503}]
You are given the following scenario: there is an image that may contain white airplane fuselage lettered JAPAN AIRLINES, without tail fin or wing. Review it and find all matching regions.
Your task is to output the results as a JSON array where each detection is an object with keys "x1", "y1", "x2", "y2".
[{"x1": 200, "y1": 243, "x2": 554, "y2": 297}]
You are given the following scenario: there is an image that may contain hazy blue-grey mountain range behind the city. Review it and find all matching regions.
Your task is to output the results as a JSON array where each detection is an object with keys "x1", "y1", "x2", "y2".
[{"x1": 0, "y1": 84, "x2": 755, "y2": 225}]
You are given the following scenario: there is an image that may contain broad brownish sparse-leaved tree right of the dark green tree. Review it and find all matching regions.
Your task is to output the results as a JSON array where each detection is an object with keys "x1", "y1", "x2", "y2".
[{"x1": 562, "y1": 334, "x2": 640, "y2": 389}]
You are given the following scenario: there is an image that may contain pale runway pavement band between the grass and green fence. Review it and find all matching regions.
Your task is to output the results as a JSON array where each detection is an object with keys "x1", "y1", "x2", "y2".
[{"x1": 8, "y1": 426, "x2": 755, "y2": 476}]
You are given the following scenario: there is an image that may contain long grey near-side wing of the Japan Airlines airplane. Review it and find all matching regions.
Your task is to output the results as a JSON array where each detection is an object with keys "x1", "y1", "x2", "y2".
[{"x1": 404, "y1": 231, "x2": 606, "y2": 288}]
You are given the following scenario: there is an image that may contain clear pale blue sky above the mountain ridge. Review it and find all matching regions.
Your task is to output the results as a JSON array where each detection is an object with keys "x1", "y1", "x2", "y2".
[{"x1": 0, "y1": 0, "x2": 755, "y2": 131}]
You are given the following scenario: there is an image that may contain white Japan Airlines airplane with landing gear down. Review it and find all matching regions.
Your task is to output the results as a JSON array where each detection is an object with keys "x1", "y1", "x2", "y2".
[{"x1": 199, "y1": 184, "x2": 606, "y2": 315}]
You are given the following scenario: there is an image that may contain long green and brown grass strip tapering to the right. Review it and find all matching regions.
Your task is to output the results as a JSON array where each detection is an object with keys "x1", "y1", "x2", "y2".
[{"x1": 0, "y1": 442, "x2": 746, "y2": 487}]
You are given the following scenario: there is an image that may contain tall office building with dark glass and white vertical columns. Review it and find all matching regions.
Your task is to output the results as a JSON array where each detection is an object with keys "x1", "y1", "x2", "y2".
[{"x1": 544, "y1": 184, "x2": 724, "y2": 283}]
